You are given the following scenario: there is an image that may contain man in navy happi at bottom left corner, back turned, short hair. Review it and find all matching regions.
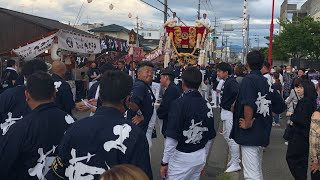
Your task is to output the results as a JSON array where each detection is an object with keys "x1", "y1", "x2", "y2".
[{"x1": 0, "y1": 72, "x2": 74, "y2": 180}]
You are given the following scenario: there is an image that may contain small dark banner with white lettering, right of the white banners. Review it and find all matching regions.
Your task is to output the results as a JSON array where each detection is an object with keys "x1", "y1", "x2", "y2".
[{"x1": 101, "y1": 36, "x2": 129, "y2": 53}]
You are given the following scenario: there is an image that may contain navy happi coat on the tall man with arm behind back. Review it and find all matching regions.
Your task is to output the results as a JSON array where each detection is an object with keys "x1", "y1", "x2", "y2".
[{"x1": 230, "y1": 71, "x2": 285, "y2": 147}]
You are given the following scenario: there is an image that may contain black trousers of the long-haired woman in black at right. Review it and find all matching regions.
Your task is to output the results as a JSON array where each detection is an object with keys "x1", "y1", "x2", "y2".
[{"x1": 286, "y1": 133, "x2": 309, "y2": 180}]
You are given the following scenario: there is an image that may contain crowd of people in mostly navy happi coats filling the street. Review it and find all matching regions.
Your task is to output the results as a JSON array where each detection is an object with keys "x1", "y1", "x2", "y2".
[{"x1": 0, "y1": 51, "x2": 320, "y2": 180}]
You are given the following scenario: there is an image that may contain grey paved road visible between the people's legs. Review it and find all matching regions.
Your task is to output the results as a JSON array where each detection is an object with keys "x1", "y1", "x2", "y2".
[{"x1": 75, "y1": 109, "x2": 293, "y2": 180}]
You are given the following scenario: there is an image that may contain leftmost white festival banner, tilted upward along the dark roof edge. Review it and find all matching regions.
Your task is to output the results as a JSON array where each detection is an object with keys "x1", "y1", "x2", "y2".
[{"x1": 13, "y1": 34, "x2": 56, "y2": 61}]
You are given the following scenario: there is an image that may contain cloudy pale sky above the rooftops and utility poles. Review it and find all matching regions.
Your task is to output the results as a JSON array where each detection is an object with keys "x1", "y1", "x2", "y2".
[{"x1": 0, "y1": 0, "x2": 306, "y2": 47}]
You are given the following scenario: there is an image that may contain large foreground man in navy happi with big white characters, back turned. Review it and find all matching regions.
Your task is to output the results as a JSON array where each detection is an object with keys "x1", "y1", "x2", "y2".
[{"x1": 46, "y1": 71, "x2": 152, "y2": 180}]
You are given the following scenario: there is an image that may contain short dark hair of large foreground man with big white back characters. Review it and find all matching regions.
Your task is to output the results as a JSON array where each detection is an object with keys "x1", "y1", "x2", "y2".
[{"x1": 99, "y1": 71, "x2": 133, "y2": 103}]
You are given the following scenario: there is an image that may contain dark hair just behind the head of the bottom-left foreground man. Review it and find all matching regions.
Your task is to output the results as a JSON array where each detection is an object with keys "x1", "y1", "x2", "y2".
[{"x1": 21, "y1": 59, "x2": 48, "y2": 78}]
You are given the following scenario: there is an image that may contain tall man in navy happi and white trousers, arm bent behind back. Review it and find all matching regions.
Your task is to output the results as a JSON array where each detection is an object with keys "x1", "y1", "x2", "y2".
[{"x1": 230, "y1": 51, "x2": 285, "y2": 180}]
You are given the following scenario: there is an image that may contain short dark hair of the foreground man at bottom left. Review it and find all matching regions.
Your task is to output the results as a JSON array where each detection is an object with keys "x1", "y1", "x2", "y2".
[{"x1": 26, "y1": 71, "x2": 55, "y2": 101}]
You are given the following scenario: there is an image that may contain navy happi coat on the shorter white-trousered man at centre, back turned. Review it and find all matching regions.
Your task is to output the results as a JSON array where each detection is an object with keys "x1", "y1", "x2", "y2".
[{"x1": 165, "y1": 90, "x2": 216, "y2": 153}]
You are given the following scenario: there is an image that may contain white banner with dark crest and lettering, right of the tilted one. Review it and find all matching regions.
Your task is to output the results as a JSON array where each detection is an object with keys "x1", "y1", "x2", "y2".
[{"x1": 57, "y1": 30, "x2": 101, "y2": 54}]
